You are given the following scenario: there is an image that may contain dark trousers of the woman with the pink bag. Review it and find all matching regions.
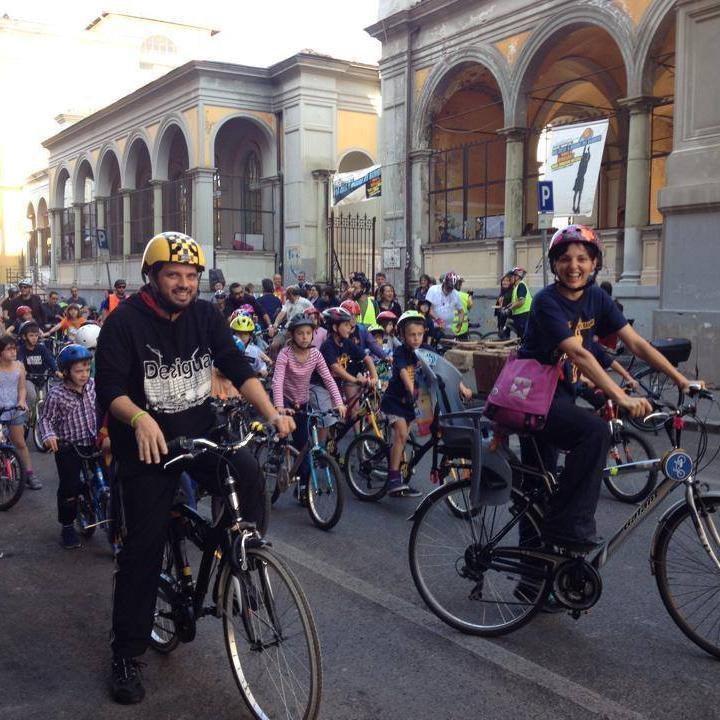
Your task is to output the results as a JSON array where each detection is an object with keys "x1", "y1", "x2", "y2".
[{"x1": 520, "y1": 386, "x2": 610, "y2": 540}]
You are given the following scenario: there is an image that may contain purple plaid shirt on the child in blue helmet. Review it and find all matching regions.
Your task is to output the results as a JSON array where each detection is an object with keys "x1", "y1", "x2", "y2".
[{"x1": 40, "y1": 378, "x2": 97, "y2": 444}]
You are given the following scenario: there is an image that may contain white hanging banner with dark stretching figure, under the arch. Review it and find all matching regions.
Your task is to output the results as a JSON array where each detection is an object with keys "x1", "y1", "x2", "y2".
[{"x1": 545, "y1": 119, "x2": 608, "y2": 217}]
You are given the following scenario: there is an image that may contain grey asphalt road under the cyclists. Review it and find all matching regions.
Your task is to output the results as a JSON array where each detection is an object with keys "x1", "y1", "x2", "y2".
[{"x1": 0, "y1": 428, "x2": 720, "y2": 720}]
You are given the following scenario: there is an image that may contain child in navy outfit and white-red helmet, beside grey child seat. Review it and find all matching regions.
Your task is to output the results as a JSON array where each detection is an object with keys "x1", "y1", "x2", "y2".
[{"x1": 380, "y1": 310, "x2": 425, "y2": 497}]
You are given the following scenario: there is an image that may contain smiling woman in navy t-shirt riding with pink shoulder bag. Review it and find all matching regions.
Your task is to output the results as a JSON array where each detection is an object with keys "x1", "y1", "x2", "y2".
[{"x1": 518, "y1": 225, "x2": 704, "y2": 552}]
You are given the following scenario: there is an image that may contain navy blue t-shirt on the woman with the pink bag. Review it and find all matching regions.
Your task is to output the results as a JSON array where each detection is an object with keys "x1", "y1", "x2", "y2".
[{"x1": 518, "y1": 285, "x2": 627, "y2": 388}]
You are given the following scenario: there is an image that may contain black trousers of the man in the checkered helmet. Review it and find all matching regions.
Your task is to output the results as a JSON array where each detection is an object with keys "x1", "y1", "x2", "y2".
[{"x1": 111, "y1": 450, "x2": 265, "y2": 657}]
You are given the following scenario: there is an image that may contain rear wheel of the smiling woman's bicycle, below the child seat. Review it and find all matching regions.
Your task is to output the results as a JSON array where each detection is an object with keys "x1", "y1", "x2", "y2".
[{"x1": 408, "y1": 478, "x2": 550, "y2": 637}]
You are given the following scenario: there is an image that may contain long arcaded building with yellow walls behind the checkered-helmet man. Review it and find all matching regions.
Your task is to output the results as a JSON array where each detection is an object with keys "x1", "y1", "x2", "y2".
[{"x1": 23, "y1": 52, "x2": 380, "y2": 294}]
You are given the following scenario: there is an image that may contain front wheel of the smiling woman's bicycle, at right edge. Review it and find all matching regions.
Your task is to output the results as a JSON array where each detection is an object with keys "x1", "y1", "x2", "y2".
[{"x1": 652, "y1": 493, "x2": 720, "y2": 658}]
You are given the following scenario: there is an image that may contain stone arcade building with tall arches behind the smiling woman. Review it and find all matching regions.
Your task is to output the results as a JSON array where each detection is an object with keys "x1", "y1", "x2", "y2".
[{"x1": 368, "y1": 0, "x2": 720, "y2": 380}]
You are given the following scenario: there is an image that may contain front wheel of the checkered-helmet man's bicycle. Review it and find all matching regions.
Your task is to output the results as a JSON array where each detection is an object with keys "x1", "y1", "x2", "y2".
[{"x1": 221, "y1": 548, "x2": 322, "y2": 720}]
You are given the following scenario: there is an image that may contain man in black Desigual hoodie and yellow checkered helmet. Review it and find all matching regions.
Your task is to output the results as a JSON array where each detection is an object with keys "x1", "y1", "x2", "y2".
[{"x1": 96, "y1": 232, "x2": 294, "y2": 704}]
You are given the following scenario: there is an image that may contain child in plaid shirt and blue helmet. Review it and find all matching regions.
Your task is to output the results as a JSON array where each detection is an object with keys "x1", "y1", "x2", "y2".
[{"x1": 40, "y1": 344, "x2": 97, "y2": 549}]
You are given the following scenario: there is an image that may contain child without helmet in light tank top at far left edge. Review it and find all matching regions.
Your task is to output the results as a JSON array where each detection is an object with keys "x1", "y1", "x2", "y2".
[{"x1": 0, "y1": 335, "x2": 42, "y2": 490}]
